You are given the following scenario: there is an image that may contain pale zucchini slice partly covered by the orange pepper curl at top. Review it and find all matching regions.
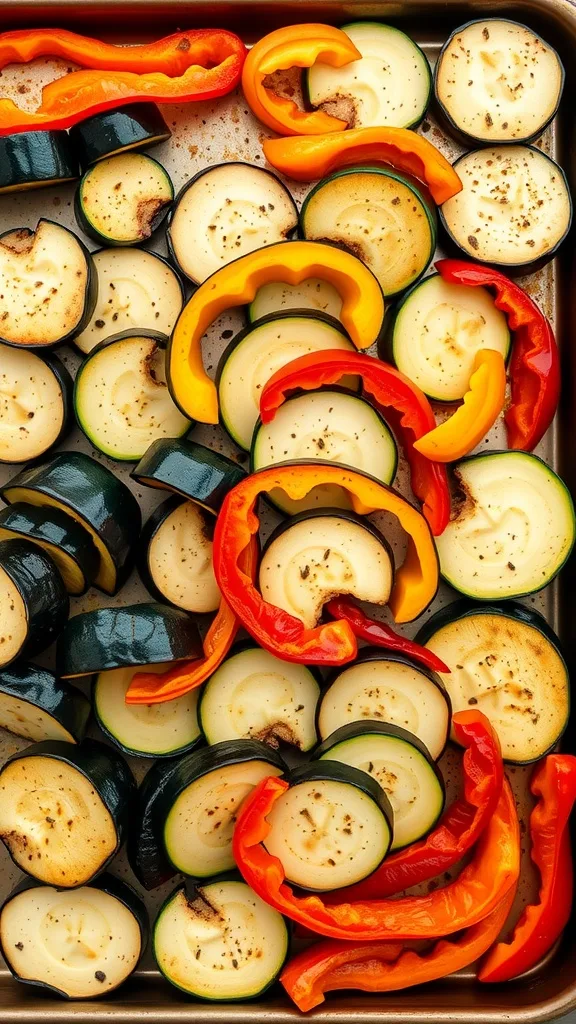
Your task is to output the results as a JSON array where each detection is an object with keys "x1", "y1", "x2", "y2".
[{"x1": 306, "y1": 22, "x2": 431, "y2": 128}]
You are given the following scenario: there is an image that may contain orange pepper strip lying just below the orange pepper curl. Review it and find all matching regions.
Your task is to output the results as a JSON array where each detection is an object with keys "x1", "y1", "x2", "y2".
[{"x1": 262, "y1": 127, "x2": 462, "y2": 206}]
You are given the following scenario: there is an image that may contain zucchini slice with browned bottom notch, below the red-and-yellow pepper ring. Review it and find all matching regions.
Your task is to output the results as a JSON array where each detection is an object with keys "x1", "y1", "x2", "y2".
[{"x1": 198, "y1": 642, "x2": 320, "y2": 752}]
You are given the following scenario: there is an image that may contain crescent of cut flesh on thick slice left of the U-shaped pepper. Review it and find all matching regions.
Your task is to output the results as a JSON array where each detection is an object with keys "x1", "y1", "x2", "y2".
[{"x1": 164, "y1": 761, "x2": 280, "y2": 879}]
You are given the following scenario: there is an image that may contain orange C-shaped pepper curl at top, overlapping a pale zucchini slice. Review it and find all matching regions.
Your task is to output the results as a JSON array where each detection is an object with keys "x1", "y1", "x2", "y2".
[{"x1": 242, "y1": 25, "x2": 362, "y2": 135}]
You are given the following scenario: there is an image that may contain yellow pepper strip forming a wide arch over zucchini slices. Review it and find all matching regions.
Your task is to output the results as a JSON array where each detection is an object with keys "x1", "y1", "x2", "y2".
[{"x1": 168, "y1": 241, "x2": 384, "y2": 423}]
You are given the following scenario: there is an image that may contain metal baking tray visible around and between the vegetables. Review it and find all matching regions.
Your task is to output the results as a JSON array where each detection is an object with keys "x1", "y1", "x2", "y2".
[{"x1": 0, "y1": 0, "x2": 576, "y2": 1024}]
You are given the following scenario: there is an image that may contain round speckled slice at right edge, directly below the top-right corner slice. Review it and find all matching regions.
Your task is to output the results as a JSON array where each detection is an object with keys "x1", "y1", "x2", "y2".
[{"x1": 440, "y1": 145, "x2": 572, "y2": 272}]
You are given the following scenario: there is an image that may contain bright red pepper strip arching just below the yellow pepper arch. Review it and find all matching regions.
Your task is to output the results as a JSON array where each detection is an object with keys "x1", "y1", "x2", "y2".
[{"x1": 260, "y1": 349, "x2": 450, "y2": 537}]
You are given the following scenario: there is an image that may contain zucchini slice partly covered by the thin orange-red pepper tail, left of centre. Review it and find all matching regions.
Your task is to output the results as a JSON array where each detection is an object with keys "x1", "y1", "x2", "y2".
[{"x1": 92, "y1": 665, "x2": 200, "y2": 758}]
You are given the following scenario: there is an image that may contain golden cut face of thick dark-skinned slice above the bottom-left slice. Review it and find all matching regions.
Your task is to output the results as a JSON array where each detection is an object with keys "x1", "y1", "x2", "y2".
[{"x1": 0, "y1": 756, "x2": 118, "y2": 888}]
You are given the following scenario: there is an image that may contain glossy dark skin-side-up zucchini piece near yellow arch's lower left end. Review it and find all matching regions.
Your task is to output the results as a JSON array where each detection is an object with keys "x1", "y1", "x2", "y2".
[{"x1": 130, "y1": 437, "x2": 246, "y2": 512}]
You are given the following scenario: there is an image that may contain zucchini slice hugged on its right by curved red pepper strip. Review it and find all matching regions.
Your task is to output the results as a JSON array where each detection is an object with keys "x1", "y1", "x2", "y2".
[{"x1": 388, "y1": 273, "x2": 510, "y2": 401}]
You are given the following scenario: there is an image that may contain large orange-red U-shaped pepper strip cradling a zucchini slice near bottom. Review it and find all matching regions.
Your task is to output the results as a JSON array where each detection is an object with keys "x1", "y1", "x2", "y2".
[{"x1": 233, "y1": 777, "x2": 520, "y2": 942}]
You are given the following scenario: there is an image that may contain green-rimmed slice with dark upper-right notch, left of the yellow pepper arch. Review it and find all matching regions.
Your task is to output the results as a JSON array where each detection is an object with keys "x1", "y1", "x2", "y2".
[{"x1": 74, "y1": 330, "x2": 192, "y2": 462}]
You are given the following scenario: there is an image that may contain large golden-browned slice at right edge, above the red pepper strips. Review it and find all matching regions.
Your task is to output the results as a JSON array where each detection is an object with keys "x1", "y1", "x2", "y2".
[{"x1": 417, "y1": 601, "x2": 570, "y2": 764}]
